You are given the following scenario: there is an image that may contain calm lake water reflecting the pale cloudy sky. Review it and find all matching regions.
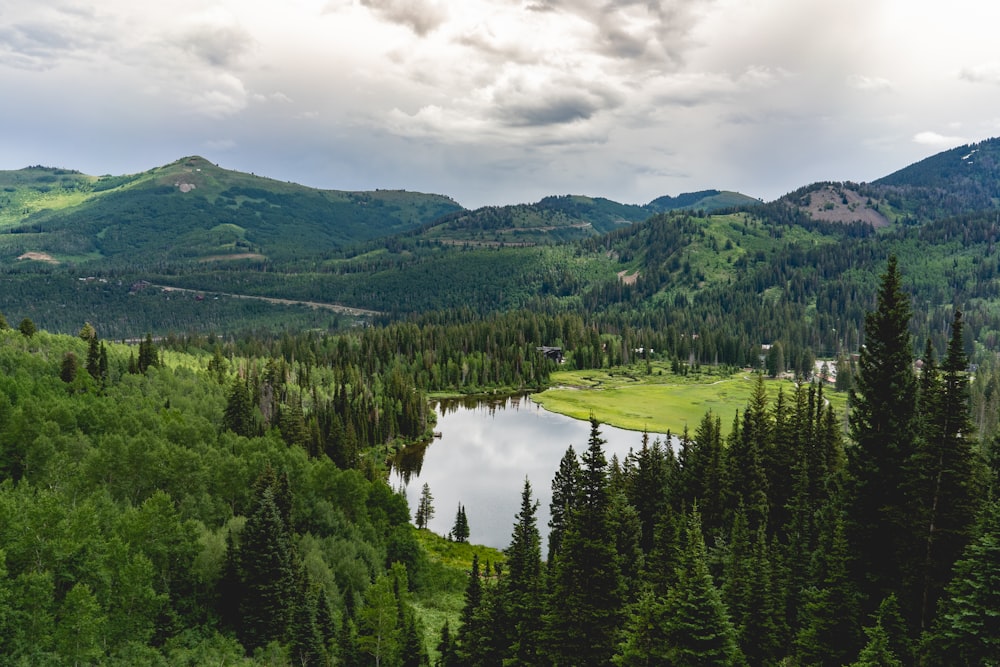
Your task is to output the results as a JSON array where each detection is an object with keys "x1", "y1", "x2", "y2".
[{"x1": 392, "y1": 396, "x2": 665, "y2": 558}]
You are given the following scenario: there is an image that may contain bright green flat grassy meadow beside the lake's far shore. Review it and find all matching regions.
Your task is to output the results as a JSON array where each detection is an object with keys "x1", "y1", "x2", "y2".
[{"x1": 532, "y1": 364, "x2": 847, "y2": 434}]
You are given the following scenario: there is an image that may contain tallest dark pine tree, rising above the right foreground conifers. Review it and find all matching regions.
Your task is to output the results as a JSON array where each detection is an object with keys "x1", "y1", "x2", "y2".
[{"x1": 848, "y1": 257, "x2": 920, "y2": 613}]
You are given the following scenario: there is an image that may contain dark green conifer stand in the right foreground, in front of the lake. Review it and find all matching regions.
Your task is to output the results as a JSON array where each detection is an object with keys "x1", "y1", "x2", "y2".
[{"x1": 440, "y1": 259, "x2": 1000, "y2": 667}]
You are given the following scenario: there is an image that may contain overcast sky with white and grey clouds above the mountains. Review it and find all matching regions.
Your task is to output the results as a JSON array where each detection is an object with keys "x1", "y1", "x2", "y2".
[{"x1": 0, "y1": 0, "x2": 1000, "y2": 208}]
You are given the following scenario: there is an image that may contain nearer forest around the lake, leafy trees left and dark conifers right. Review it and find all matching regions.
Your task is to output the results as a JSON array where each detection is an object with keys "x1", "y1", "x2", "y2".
[{"x1": 0, "y1": 253, "x2": 1000, "y2": 666}]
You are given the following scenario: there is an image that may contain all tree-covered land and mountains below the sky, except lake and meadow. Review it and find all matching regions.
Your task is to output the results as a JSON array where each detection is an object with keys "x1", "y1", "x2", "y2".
[{"x1": 0, "y1": 140, "x2": 1000, "y2": 667}]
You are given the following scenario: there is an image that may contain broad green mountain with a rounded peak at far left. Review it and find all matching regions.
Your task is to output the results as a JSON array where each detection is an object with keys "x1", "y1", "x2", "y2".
[{"x1": 0, "y1": 156, "x2": 462, "y2": 264}]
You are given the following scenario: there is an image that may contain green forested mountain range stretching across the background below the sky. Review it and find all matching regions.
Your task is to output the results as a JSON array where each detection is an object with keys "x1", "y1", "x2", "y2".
[{"x1": 0, "y1": 140, "x2": 1000, "y2": 344}]
